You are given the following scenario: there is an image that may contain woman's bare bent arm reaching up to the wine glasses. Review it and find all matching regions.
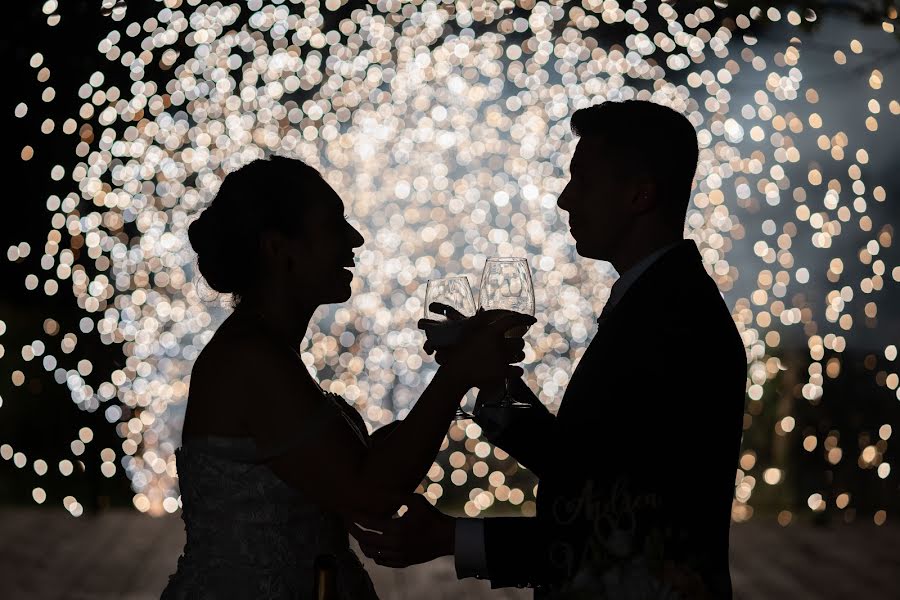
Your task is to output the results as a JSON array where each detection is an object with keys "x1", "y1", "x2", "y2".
[{"x1": 247, "y1": 316, "x2": 521, "y2": 515}]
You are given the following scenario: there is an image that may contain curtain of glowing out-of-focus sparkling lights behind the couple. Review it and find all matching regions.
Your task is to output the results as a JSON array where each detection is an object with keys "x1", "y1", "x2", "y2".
[{"x1": 0, "y1": 0, "x2": 900, "y2": 525}]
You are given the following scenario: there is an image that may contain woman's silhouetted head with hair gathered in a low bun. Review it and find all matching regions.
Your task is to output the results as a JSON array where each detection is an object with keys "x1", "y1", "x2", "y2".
[{"x1": 188, "y1": 156, "x2": 364, "y2": 312}]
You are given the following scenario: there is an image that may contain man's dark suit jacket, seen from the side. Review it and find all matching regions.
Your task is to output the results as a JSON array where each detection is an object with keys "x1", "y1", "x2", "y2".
[{"x1": 484, "y1": 240, "x2": 747, "y2": 598}]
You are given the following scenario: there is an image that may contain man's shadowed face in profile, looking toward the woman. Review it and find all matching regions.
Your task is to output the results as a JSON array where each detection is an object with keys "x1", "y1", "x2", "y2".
[{"x1": 557, "y1": 136, "x2": 636, "y2": 260}]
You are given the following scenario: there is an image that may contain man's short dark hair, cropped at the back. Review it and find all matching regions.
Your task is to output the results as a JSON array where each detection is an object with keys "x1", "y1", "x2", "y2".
[{"x1": 571, "y1": 100, "x2": 699, "y2": 224}]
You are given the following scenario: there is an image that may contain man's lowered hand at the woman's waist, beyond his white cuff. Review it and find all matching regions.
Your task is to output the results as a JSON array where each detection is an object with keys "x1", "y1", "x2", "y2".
[{"x1": 350, "y1": 494, "x2": 456, "y2": 569}]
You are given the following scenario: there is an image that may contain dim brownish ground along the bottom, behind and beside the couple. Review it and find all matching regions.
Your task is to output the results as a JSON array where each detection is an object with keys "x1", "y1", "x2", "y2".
[{"x1": 0, "y1": 508, "x2": 900, "y2": 600}]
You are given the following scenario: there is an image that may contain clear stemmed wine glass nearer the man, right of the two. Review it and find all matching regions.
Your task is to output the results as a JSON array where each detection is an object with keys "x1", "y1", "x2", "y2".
[{"x1": 479, "y1": 258, "x2": 534, "y2": 408}]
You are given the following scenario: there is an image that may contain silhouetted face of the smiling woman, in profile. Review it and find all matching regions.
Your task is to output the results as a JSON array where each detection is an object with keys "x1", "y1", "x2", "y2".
[{"x1": 262, "y1": 181, "x2": 364, "y2": 305}]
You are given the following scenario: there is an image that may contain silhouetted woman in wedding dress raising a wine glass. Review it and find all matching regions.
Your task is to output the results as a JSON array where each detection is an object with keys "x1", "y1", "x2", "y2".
[{"x1": 163, "y1": 157, "x2": 533, "y2": 600}]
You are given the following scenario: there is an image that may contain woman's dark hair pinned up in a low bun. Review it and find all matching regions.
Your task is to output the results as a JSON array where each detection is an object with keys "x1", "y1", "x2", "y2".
[{"x1": 188, "y1": 156, "x2": 322, "y2": 306}]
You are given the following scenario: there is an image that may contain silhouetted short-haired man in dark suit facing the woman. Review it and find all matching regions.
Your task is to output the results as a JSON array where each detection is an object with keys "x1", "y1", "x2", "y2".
[{"x1": 354, "y1": 101, "x2": 747, "y2": 598}]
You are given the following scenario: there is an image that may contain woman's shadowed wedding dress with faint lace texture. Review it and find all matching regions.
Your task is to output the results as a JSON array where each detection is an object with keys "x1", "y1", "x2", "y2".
[{"x1": 163, "y1": 396, "x2": 376, "y2": 599}]
